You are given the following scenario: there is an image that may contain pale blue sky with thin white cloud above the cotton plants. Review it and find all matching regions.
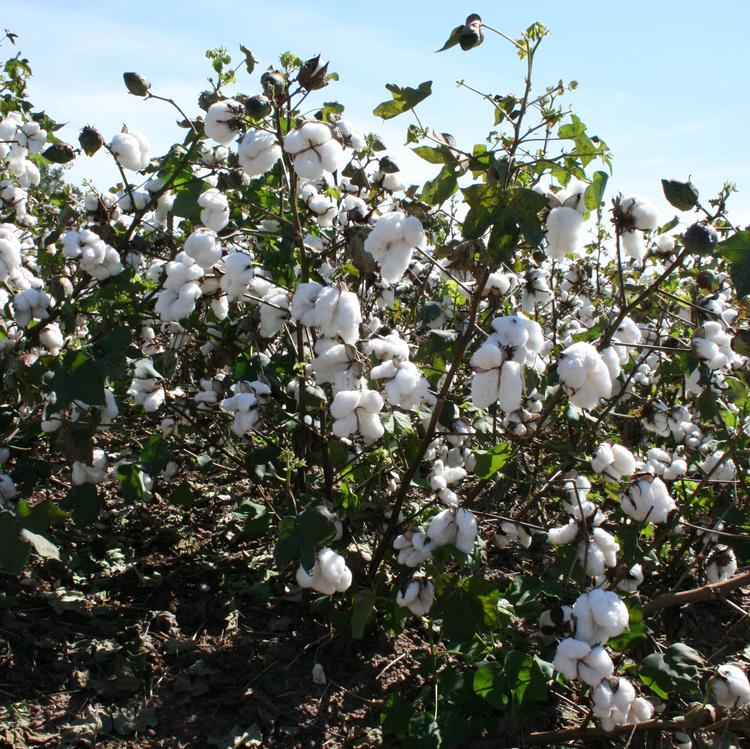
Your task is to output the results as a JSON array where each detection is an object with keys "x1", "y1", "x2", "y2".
[{"x1": 3, "y1": 0, "x2": 750, "y2": 221}]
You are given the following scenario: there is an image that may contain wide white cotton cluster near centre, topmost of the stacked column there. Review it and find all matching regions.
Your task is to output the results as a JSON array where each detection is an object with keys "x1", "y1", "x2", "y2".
[{"x1": 291, "y1": 281, "x2": 362, "y2": 344}]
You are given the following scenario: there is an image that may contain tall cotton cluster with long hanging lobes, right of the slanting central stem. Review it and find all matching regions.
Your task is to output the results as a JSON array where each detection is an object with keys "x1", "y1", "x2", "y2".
[{"x1": 469, "y1": 314, "x2": 544, "y2": 413}]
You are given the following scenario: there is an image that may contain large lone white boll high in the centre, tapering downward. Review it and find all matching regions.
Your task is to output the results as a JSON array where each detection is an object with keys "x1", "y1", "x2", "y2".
[{"x1": 364, "y1": 211, "x2": 425, "y2": 283}]
